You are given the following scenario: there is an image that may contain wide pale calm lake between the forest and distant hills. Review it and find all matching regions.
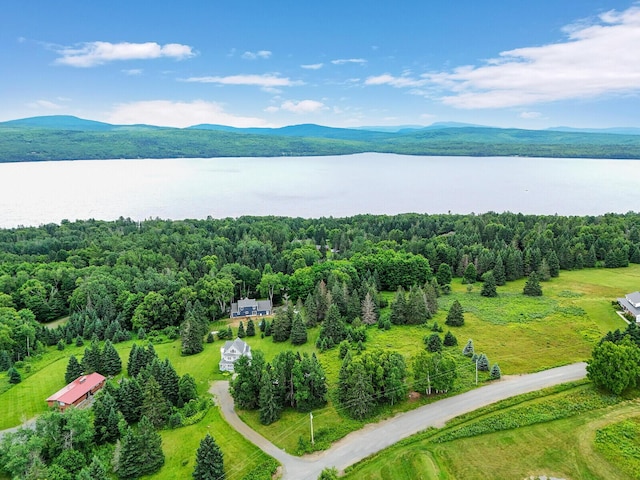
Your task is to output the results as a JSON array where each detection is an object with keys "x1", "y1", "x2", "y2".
[{"x1": 0, "y1": 153, "x2": 640, "y2": 228}]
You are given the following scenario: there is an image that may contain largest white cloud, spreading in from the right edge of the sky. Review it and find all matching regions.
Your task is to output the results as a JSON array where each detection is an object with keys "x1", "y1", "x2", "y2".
[{"x1": 425, "y1": 7, "x2": 640, "y2": 109}]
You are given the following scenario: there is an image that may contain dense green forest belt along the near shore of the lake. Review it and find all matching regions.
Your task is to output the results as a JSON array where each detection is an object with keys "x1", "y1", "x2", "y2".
[{"x1": 0, "y1": 213, "x2": 640, "y2": 364}]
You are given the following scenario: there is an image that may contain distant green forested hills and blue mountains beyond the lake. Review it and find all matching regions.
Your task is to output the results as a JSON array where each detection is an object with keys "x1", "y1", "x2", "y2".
[{"x1": 0, "y1": 115, "x2": 640, "y2": 162}]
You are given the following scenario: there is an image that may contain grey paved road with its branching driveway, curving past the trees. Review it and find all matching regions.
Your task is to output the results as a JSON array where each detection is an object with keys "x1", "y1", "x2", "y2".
[{"x1": 210, "y1": 363, "x2": 586, "y2": 480}]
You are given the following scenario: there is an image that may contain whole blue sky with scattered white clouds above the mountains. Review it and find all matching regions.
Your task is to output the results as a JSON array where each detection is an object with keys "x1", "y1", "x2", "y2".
[{"x1": 0, "y1": 0, "x2": 640, "y2": 128}]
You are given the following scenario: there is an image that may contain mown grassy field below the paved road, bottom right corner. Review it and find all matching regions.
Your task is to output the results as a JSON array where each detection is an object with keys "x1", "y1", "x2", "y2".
[{"x1": 345, "y1": 385, "x2": 640, "y2": 480}]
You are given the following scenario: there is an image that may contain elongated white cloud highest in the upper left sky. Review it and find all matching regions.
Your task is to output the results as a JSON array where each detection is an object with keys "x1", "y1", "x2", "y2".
[{"x1": 55, "y1": 42, "x2": 195, "y2": 67}]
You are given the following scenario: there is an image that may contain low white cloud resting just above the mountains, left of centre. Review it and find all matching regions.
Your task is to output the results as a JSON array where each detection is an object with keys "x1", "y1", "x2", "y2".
[{"x1": 105, "y1": 100, "x2": 267, "y2": 128}]
